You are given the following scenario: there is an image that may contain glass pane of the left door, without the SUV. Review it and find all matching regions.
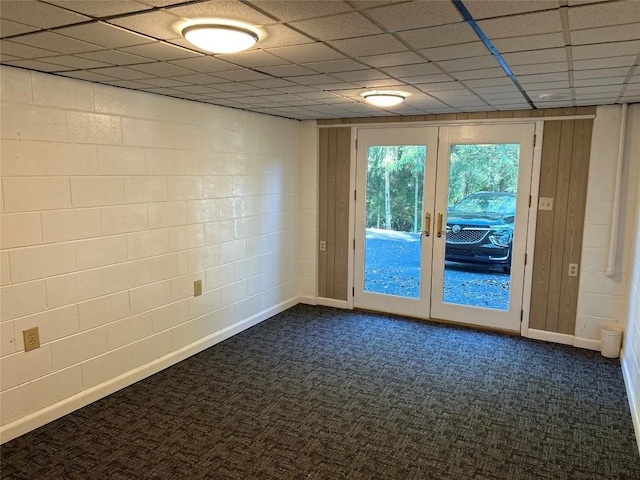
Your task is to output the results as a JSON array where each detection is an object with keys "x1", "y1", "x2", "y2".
[{"x1": 364, "y1": 145, "x2": 427, "y2": 298}]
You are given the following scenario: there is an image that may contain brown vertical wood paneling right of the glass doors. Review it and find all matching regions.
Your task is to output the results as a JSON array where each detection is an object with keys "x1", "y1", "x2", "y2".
[{"x1": 529, "y1": 120, "x2": 593, "y2": 335}]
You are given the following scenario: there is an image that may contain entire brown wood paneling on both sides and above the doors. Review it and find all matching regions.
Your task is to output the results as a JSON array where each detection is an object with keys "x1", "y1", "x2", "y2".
[{"x1": 318, "y1": 107, "x2": 596, "y2": 335}]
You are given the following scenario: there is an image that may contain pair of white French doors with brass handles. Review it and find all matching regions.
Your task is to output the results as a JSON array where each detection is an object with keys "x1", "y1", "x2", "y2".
[{"x1": 354, "y1": 124, "x2": 535, "y2": 331}]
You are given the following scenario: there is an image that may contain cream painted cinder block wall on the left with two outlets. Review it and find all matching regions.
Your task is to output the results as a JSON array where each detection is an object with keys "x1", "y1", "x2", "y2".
[{"x1": 0, "y1": 67, "x2": 304, "y2": 440}]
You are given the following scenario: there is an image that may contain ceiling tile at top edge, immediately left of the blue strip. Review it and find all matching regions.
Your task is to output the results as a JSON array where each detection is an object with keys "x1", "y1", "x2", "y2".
[{"x1": 366, "y1": 2, "x2": 463, "y2": 32}]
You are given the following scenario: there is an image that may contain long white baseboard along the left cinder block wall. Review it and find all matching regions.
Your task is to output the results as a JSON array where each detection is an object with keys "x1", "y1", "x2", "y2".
[{"x1": 0, "y1": 297, "x2": 299, "y2": 444}]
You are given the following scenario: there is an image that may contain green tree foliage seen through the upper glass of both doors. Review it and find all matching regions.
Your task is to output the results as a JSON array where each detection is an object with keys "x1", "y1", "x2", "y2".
[{"x1": 366, "y1": 144, "x2": 520, "y2": 232}]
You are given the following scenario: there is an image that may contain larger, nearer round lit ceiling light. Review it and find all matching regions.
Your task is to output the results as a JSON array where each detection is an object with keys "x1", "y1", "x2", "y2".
[{"x1": 182, "y1": 23, "x2": 259, "y2": 53}]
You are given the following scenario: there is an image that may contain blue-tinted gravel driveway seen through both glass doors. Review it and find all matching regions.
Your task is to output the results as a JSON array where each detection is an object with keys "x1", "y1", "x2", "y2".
[{"x1": 365, "y1": 229, "x2": 510, "y2": 310}]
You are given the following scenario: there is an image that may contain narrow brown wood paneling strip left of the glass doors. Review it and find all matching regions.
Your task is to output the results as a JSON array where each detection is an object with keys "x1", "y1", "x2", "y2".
[{"x1": 318, "y1": 128, "x2": 351, "y2": 300}]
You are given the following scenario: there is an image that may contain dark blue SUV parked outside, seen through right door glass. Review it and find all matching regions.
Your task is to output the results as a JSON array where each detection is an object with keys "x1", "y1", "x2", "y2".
[{"x1": 445, "y1": 192, "x2": 516, "y2": 273}]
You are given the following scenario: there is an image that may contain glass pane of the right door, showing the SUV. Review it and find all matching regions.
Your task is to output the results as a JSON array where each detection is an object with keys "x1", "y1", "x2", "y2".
[{"x1": 443, "y1": 144, "x2": 520, "y2": 310}]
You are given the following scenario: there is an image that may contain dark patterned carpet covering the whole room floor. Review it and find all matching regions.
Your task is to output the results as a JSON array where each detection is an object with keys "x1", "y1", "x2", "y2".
[{"x1": 1, "y1": 305, "x2": 640, "y2": 480}]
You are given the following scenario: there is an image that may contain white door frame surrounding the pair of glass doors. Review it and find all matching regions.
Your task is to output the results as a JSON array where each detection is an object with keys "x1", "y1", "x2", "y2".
[{"x1": 341, "y1": 122, "x2": 544, "y2": 337}]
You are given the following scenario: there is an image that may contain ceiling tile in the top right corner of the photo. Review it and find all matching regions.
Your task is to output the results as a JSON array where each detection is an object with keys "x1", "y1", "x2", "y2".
[{"x1": 569, "y1": 0, "x2": 640, "y2": 29}]
